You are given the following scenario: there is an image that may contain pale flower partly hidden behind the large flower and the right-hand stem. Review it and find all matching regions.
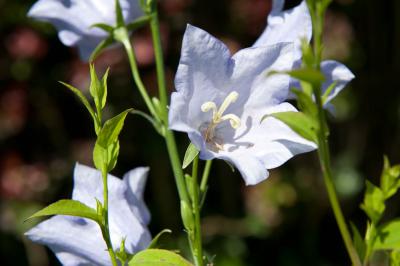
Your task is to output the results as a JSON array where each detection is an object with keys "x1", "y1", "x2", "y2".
[{"x1": 253, "y1": 0, "x2": 354, "y2": 104}]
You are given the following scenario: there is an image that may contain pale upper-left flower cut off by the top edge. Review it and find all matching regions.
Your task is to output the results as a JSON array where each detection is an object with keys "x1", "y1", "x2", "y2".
[{"x1": 28, "y1": 0, "x2": 142, "y2": 60}]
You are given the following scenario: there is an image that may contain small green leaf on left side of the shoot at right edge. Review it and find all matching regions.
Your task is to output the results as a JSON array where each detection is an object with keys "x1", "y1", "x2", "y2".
[{"x1": 360, "y1": 180, "x2": 385, "y2": 224}]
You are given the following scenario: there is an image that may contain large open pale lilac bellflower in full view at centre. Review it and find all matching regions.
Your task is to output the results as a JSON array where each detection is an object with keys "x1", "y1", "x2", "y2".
[{"x1": 169, "y1": 25, "x2": 315, "y2": 185}]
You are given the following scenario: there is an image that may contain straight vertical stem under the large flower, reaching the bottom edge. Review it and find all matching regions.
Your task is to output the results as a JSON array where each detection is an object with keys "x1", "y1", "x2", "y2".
[{"x1": 192, "y1": 156, "x2": 203, "y2": 266}]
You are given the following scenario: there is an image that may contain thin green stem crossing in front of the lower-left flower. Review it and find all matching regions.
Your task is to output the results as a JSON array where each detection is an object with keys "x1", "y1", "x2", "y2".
[{"x1": 100, "y1": 167, "x2": 118, "y2": 266}]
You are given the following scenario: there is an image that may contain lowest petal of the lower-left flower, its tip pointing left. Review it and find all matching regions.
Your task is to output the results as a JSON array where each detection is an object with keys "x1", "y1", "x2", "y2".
[{"x1": 25, "y1": 215, "x2": 111, "y2": 266}]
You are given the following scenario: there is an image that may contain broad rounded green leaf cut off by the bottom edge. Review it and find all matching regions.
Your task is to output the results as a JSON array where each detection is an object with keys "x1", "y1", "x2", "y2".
[{"x1": 129, "y1": 249, "x2": 193, "y2": 266}]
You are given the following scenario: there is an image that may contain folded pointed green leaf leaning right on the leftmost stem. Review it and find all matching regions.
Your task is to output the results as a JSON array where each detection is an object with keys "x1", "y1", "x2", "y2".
[{"x1": 97, "y1": 109, "x2": 132, "y2": 148}]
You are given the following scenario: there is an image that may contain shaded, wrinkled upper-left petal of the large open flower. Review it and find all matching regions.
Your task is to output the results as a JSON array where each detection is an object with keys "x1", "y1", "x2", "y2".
[{"x1": 169, "y1": 25, "x2": 233, "y2": 133}]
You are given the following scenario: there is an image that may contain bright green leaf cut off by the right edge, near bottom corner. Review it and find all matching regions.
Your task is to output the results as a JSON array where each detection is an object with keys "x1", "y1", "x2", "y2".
[{"x1": 374, "y1": 219, "x2": 400, "y2": 250}]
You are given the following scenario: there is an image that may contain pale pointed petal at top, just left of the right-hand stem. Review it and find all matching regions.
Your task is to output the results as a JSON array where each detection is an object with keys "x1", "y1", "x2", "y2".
[{"x1": 253, "y1": 1, "x2": 312, "y2": 64}]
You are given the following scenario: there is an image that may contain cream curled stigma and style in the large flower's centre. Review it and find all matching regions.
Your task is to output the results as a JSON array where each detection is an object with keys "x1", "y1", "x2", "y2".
[{"x1": 201, "y1": 91, "x2": 240, "y2": 150}]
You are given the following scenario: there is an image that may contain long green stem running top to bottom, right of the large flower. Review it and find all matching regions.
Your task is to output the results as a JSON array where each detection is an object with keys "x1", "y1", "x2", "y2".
[{"x1": 311, "y1": 2, "x2": 361, "y2": 266}]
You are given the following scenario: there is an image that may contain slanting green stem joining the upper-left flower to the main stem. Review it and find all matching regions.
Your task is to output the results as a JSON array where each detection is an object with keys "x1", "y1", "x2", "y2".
[{"x1": 119, "y1": 28, "x2": 158, "y2": 119}]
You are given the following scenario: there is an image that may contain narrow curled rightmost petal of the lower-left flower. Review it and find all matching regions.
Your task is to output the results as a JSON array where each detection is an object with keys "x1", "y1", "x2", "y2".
[{"x1": 123, "y1": 167, "x2": 150, "y2": 225}]
